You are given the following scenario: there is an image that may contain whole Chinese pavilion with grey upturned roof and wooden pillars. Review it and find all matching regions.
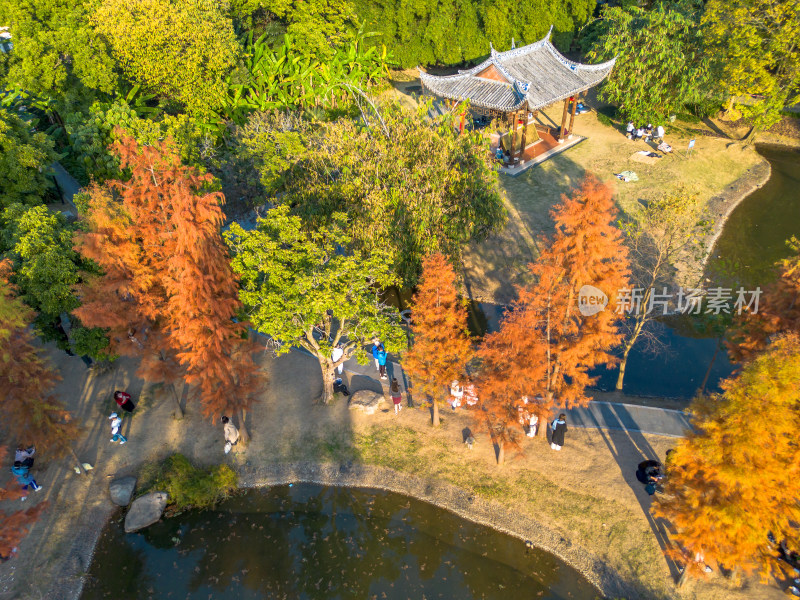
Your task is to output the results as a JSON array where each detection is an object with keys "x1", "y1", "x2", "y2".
[{"x1": 420, "y1": 27, "x2": 616, "y2": 164}]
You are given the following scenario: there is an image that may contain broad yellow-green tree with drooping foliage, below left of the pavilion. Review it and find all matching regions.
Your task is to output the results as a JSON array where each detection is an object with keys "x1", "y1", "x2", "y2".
[{"x1": 260, "y1": 104, "x2": 506, "y2": 285}]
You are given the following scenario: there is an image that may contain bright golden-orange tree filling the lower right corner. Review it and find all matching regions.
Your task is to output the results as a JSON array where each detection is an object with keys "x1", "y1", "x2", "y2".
[{"x1": 653, "y1": 334, "x2": 800, "y2": 578}]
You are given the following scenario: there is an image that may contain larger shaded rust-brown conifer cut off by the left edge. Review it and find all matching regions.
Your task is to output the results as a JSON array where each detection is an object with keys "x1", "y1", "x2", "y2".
[{"x1": 0, "y1": 261, "x2": 80, "y2": 465}]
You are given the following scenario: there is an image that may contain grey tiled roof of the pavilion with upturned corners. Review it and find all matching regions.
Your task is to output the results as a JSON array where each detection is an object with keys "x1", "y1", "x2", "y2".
[{"x1": 420, "y1": 27, "x2": 616, "y2": 112}]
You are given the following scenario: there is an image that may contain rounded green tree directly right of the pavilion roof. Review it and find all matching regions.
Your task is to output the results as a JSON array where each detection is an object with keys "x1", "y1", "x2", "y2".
[{"x1": 589, "y1": 4, "x2": 709, "y2": 123}]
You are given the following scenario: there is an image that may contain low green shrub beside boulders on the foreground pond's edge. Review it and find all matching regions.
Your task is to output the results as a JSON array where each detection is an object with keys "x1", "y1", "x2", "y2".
[{"x1": 140, "y1": 454, "x2": 239, "y2": 514}]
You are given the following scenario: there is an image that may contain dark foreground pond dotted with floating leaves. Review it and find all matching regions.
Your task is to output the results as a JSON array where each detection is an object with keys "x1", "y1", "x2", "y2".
[{"x1": 81, "y1": 484, "x2": 600, "y2": 600}]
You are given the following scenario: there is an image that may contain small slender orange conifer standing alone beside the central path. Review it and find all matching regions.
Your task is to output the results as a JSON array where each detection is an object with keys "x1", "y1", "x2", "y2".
[{"x1": 403, "y1": 254, "x2": 472, "y2": 427}]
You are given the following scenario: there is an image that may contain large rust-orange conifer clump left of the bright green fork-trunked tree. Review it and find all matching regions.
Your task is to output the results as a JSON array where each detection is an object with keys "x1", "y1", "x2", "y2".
[{"x1": 76, "y1": 136, "x2": 262, "y2": 439}]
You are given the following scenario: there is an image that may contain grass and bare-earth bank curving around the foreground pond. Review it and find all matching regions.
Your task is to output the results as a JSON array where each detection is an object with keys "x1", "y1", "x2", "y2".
[{"x1": 0, "y1": 347, "x2": 780, "y2": 600}]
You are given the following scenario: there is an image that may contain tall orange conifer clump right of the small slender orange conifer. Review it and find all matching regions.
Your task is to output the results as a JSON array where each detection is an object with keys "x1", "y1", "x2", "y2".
[{"x1": 479, "y1": 175, "x2": 630, "y2": 459}]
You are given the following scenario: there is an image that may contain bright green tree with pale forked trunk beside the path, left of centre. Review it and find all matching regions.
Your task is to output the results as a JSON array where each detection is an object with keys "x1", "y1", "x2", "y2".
[{"x1": 226, "y1": 207, "x2": 405, "y2": 404}]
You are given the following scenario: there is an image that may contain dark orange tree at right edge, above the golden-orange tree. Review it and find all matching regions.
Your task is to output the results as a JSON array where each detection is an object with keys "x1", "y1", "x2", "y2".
[{"x1": 728, "y1": 238, "x2": 800, "y2": 362}]
